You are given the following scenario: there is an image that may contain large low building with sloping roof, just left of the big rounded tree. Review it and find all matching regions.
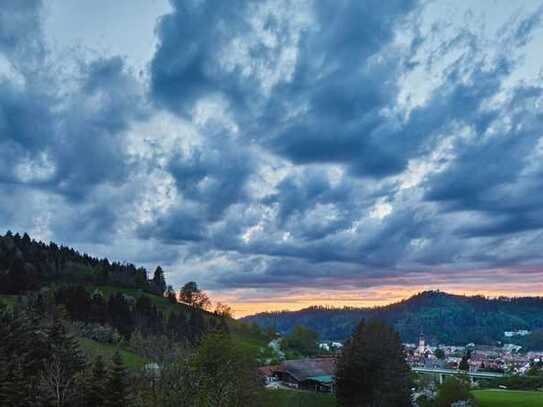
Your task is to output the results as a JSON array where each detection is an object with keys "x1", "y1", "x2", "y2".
[{"x1": 275, "y1": 358, "x2": 336, "y2": 393}]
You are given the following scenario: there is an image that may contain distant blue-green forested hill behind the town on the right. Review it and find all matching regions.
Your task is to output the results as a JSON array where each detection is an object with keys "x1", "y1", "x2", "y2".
[{"x1": 243, "y1": 291, "x2": 543, "y2": 344}]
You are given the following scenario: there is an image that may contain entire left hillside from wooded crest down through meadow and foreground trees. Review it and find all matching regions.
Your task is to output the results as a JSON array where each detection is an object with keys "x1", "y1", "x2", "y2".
[{"x1": 0, "y1": 233, "x2": 274, "y2": 407}]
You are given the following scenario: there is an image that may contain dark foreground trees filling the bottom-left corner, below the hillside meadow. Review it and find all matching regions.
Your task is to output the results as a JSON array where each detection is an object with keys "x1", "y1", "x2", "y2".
[{"x1": 0, "y1": 298, "x2": 261, "y2": 407}]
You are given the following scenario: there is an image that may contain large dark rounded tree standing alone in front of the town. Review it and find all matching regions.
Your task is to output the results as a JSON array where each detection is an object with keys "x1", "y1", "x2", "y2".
[{"x1": 336, "y1": 321, "x2": 411, "y2": 407}]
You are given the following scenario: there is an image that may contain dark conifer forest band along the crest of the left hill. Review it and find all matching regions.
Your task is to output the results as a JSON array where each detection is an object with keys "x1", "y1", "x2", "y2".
[{"x1": 0, "y1": 231, "x2": 166, "y2": 295}]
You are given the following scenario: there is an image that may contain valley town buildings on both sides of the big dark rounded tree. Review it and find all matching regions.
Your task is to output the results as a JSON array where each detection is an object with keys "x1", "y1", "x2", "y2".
[{"x1": 258, "y1": 330, "x2": 543, "y2": 395}]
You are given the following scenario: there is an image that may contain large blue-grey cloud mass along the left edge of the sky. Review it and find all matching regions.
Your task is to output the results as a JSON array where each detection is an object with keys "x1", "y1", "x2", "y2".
[{"x1": 0, "y1": 1, "x2": 149, "y2": 242}]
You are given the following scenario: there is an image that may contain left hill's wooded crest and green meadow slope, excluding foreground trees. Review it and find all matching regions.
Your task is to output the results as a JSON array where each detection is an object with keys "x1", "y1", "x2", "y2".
[{"x1": 0, "y1": 232, "x2": 231, "y2": 357}]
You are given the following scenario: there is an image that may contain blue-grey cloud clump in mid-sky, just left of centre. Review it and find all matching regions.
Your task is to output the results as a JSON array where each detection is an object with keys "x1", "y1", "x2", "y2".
[{"x1": 139, "y1": 134, "x2": 256, "y2": 248}]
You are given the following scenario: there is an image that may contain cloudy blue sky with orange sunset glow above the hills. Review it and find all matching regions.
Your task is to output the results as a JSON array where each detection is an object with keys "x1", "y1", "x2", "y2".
[{"x1": 0, "y1": 0, "x2": 543, "y2": 316}]
